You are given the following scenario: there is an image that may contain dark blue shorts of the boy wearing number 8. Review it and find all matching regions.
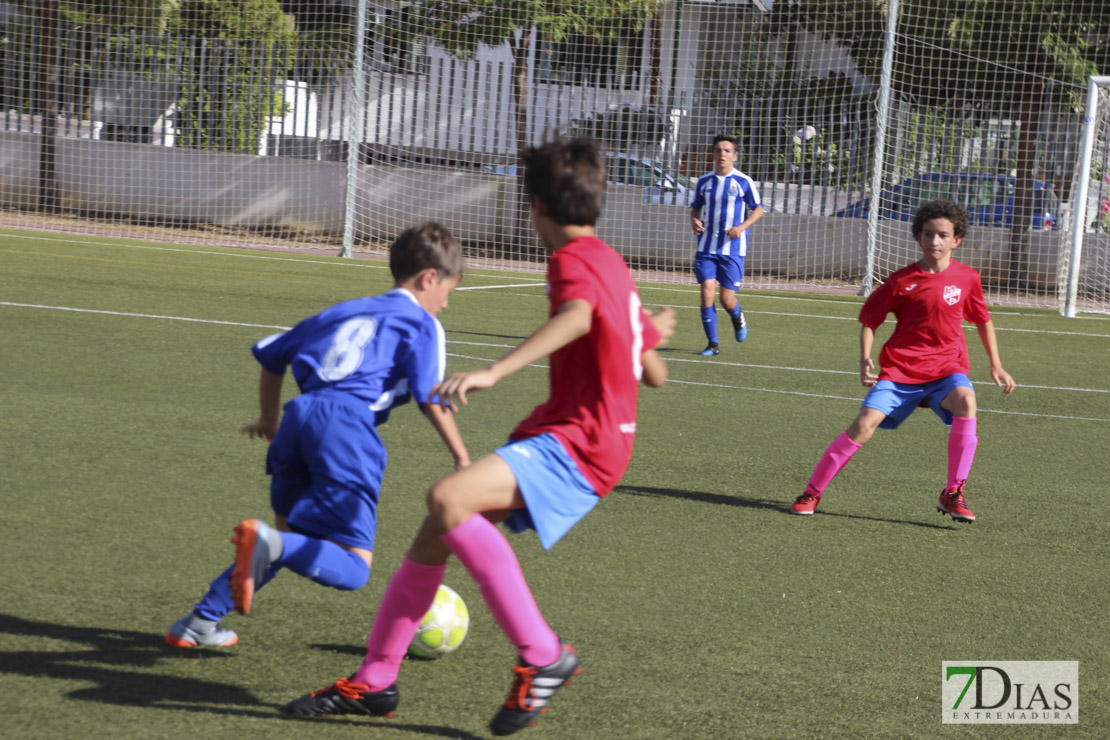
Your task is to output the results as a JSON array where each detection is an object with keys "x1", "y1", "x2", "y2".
[{"x1": 266, "y1": 392, "x2": 386, "y2": 550}]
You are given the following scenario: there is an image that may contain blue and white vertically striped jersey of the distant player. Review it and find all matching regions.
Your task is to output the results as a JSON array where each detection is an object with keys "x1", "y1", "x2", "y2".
[{"x1": 690, "y1": 169, "x2": 760, "y2": 257}]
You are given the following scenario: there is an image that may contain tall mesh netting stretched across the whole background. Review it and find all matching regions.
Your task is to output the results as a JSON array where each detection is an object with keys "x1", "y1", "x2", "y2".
[{"x1": 0, "y1": 0, "x2": 1110, "y2": 306}]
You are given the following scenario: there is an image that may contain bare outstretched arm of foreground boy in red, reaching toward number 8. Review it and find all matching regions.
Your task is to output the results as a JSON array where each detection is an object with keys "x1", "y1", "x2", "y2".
[{"x1": 432, "y1": 298, "x2": 594, "y2": 408}]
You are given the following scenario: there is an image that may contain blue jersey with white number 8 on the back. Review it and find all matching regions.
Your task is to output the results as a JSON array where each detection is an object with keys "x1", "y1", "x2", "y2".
[{"x1": 251, "y1": 288, "x2": 447, "y2": 424}]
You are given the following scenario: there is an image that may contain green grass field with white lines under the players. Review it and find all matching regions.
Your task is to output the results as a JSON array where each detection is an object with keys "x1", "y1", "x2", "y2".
[{"x1": 0, "y1": 231, "x2": 1110, "y2": 740}]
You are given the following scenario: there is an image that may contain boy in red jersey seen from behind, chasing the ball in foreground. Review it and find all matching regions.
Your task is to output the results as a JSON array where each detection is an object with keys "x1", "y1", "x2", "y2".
[{"x1": 283, "y1": 140, "x2": 675, "y2": 734}]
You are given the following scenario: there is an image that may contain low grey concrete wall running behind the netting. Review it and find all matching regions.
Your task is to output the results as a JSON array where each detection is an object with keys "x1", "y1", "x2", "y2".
[{"x1": 0, "y1": 132, "x2": 1092, "y2": 290}]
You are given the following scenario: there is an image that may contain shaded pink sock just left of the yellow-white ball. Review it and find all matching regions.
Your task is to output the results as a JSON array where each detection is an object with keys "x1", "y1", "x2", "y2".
[{"x1": 353, "y1": 555, "x2": 447, "y2": 691}]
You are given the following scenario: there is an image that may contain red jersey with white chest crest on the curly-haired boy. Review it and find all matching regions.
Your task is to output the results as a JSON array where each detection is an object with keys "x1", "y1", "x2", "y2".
[{"x1": 859, "y1": 260, "x2": 990, "y2": 383}]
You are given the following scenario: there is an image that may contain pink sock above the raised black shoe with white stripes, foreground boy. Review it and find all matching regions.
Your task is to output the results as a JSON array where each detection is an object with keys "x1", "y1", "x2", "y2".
[{"x1": 443, "y1": 514, "x2": 562, "y2": 666}]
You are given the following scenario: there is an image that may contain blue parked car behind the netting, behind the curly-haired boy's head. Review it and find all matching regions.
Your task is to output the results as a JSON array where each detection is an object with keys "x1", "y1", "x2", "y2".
[{"x1": 836, "y1": 172, "x2": 1060, "y2": 231}]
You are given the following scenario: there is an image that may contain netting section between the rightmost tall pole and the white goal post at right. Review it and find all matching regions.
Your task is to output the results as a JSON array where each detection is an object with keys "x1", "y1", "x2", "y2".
[{"x1": 869, "y1": 1, "x2": 1096, "y2": 306}]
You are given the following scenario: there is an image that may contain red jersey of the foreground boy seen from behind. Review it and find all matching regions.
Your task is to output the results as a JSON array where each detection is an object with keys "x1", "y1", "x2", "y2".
[{"x1": 513, "y1": 236, "x2": 660, "y2": 496}]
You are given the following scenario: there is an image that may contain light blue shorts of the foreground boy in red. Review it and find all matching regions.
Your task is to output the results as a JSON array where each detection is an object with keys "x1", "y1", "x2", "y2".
[{"x1": 494, "y1": 434, "x2": 602, "y2": 550}]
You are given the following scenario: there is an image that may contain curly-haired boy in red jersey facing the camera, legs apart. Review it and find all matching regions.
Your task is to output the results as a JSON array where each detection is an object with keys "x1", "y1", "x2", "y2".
[{"x1": 790, "y1": 201, "x2": 1015, "y2": 523}]
